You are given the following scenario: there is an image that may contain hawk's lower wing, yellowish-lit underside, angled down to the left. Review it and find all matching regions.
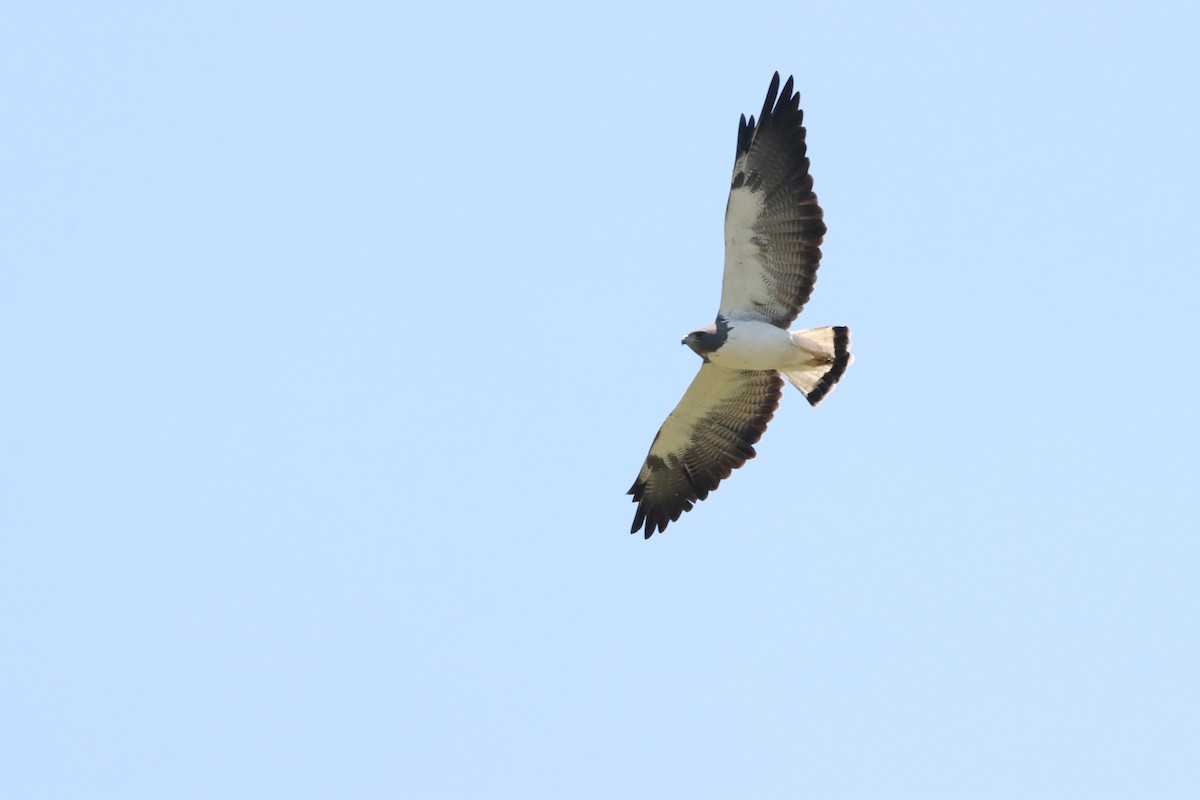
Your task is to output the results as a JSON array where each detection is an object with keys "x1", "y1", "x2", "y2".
[{"x1": 629, "y1": 363, "x2": 784, "y2": 539}]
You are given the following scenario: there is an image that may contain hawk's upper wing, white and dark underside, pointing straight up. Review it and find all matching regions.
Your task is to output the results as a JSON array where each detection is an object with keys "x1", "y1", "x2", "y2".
[{"x1": 720, "y1": 72, "x2": 826, "y2": 329}]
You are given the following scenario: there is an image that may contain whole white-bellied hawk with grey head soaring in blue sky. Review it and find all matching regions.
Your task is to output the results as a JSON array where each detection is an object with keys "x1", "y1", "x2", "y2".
[{"x1": 629, "y1": 72, "x2": 853, "y2": 539}]
